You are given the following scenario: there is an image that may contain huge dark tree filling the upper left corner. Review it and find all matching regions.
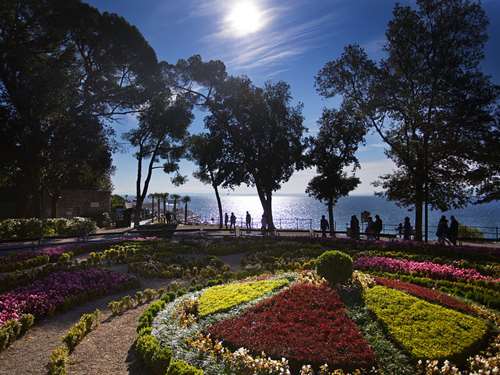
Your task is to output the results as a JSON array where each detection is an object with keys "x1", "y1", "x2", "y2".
[{"x1": 0, "y1": 0, "x2": 156, "y2": 216}]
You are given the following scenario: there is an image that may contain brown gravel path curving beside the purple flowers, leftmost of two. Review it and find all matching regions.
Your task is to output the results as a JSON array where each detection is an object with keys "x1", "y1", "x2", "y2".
[{"x1": 0, "y1": 280, "x2": 168, "y2": 375}]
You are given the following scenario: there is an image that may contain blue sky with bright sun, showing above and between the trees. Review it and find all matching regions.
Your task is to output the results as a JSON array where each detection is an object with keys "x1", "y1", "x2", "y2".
[{"x1": 88, "y1": 0, "x2": 500, "y2": 195}]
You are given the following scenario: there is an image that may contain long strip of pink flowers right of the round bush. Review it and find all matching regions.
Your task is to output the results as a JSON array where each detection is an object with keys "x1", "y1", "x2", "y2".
[{"x1": 354, "y1": 257, "x2": 498, "y2": 282}]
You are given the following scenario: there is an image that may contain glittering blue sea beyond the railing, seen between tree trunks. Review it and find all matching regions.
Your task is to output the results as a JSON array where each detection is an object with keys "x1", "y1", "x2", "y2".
[{"x1": 183, "y1": 194, "x2": 500, "y2": 238}]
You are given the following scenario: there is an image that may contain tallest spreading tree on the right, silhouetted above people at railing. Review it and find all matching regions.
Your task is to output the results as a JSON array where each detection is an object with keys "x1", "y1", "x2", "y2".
[{"x1": 316, "y1": 0, "x2": 499, "y2": 240}]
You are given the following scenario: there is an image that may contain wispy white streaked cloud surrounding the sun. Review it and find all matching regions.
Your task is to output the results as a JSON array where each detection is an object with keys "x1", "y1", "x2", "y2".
[{"x1": 186, "y1": 0, "x2": 335, "y2": 74}]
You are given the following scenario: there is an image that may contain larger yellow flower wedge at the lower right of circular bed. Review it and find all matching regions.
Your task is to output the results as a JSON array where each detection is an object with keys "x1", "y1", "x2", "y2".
[{"x1": 365, "y1": 286, "x2": 488, "y2": 359}]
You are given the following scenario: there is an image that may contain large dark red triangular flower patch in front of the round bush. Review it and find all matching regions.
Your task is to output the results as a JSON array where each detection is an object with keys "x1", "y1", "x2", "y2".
[{"x1": 208, "y1": 284, "x2": 375, "y2": 369}]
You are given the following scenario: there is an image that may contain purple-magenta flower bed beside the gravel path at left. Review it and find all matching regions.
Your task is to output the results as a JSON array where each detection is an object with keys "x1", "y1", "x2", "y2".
[{"x1": 0, "y1": 269, "x2": 136, "y2": 326}]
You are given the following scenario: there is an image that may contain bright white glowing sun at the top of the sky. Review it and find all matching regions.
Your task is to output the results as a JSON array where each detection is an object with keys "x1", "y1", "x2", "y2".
[{"x1": 226, "y1": 1, "x2": 265, "y2": 37}]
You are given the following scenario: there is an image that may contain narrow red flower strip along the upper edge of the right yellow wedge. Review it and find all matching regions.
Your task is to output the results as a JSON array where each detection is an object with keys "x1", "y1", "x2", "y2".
[{"x1": 375, "y1": 277, "x2": 474, "y2": 314}]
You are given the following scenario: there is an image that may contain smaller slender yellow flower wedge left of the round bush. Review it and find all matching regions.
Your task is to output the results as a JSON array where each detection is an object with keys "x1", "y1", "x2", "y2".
[{"x1": 198, "y1": 279, "x2": 288, "y2": 316}]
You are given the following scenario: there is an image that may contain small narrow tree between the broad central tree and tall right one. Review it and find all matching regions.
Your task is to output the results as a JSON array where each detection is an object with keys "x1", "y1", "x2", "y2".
[{"x1": 306, "y1": 108, "x2": 366, "y2": 236}]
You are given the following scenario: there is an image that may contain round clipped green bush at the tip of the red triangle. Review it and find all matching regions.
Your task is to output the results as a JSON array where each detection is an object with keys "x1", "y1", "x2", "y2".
[{"x1": 316, "y1": 250, "x2": 352, "y2": 285}]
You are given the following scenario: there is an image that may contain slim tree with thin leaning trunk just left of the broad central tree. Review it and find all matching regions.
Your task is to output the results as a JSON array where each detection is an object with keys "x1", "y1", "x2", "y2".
[{"x1": 189, "y1": 134, "x2": 226, "y2": 229}]
